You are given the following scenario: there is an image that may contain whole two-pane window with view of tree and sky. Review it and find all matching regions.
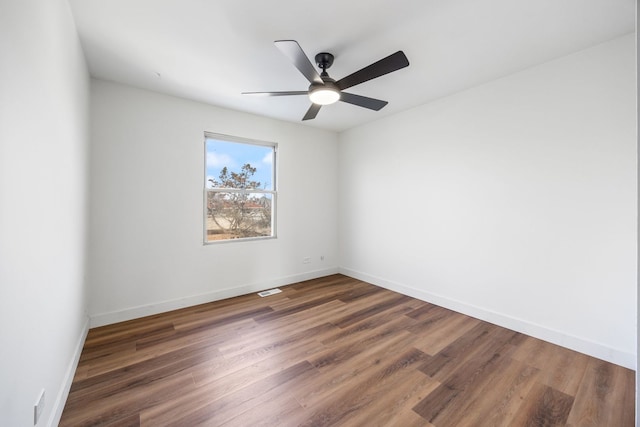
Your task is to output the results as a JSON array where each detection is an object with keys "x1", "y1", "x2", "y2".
[{"x1": 204, "y1": 133, "x2": 277, "y2": 243}]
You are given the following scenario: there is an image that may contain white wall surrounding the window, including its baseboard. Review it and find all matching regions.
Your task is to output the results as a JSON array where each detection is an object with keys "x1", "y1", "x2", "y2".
[{"x1": 89, "y1": 80, "x2": 338, "y2": 325}]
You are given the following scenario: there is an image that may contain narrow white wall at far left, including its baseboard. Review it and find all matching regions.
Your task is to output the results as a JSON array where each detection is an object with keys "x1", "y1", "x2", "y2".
[{"x1": 0, "y1": 0, "x2": 89, "y2": 427}]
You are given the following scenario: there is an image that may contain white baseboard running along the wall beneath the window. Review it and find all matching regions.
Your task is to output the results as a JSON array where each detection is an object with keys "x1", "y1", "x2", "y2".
[{"x1": 90, "y1": 267, "x2": 338, "y2": 328}]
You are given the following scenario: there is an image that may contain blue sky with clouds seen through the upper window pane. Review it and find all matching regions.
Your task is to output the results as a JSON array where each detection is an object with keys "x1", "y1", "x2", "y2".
[{"x1": 206, "y1": 138, "x2": 273, "y2": 190}]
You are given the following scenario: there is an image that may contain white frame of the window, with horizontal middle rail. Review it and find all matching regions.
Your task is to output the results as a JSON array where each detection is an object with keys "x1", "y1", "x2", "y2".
[{"x1": 202, "y1": 132, "x2": 278, "y2": 245}]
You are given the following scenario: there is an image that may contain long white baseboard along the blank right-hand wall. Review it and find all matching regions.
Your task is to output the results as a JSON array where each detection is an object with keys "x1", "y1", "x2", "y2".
[{"x1": 339, "y1": 267, "x2": 636, "y2": 370}]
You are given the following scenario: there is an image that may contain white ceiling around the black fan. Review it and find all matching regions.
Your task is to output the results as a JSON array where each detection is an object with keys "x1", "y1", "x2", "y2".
[{"x1": 69, "y1": 0, "x2": 635, "y2": 131}]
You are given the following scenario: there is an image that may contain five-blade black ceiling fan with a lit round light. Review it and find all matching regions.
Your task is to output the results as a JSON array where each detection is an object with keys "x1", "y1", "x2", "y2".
[{"x1": 242, "y1": 40, "x2": 409, "y2": 120}]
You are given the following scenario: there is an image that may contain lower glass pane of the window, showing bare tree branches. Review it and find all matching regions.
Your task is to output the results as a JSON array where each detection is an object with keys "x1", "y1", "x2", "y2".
[{"x1": 206, "y1": 191, "x2": 273, "y2": 242}]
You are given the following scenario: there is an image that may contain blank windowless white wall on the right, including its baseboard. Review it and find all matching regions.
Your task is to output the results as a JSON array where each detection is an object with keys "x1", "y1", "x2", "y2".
[{"x1": 338, "y1": 35, "x2": 637, "y2": 367}]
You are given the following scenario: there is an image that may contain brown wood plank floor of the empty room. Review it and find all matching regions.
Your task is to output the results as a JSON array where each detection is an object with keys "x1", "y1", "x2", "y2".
[{"x1": 60, "y1": 275, "x2": 635, "y2": 427}]
